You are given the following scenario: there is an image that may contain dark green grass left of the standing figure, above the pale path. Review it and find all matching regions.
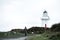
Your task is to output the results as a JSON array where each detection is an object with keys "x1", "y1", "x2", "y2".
[{"x1": 0, "y1": 32, "x2": 25, "y2": 38}]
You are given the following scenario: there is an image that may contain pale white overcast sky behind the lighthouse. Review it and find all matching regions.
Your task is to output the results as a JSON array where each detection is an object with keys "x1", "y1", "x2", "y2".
[{"x1": 0, "y1": 0, "x2": 60, "y2": 31}]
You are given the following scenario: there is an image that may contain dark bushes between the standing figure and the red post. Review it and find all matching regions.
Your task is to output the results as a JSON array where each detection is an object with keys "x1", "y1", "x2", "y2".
[{"x1": 27, "y1": 27, "x2": 48, "y2": 34}]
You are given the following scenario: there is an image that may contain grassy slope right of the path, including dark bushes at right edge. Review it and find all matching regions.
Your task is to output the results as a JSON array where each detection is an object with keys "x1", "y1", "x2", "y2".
[{"x1": 29, "y1": 23, "x2": 60, "y2": 40}]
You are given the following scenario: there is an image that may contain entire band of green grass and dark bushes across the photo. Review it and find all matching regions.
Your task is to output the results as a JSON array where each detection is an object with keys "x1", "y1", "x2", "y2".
[{"x1": 0, "y1": 23, "x2": 60, "y2": 40}]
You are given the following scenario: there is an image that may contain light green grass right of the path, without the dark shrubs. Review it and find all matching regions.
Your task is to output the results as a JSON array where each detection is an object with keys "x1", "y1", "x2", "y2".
[{"x1": 29, "y1": 32, "x2": 60, "y2": 40}]
